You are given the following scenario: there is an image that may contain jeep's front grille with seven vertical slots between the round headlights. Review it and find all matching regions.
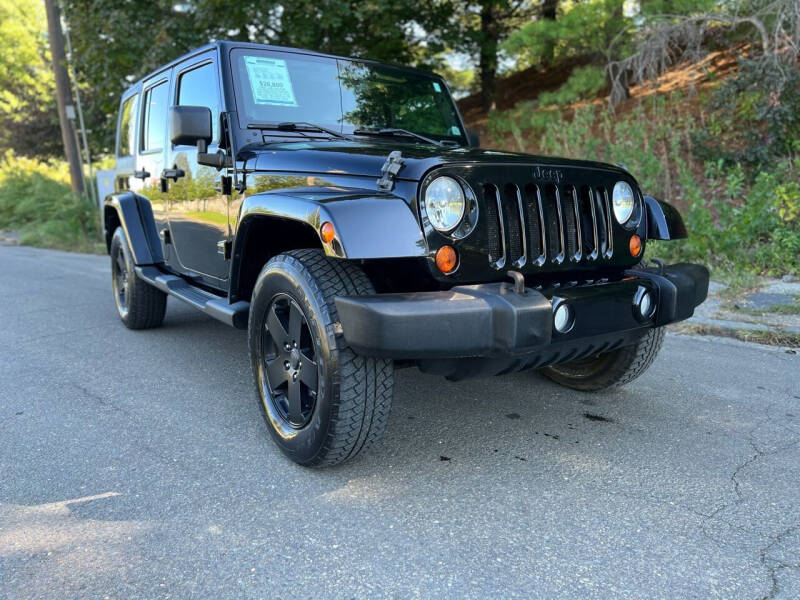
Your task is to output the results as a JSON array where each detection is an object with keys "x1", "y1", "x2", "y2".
[{"x1": 481, "y1": 183, "x2": 614, "y2": 269}]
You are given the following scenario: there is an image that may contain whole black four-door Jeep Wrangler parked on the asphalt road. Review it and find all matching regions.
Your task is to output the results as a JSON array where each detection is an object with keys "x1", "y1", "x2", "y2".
[{"x1": 103, "y1": 42, "x2": 708, "y2": 466}]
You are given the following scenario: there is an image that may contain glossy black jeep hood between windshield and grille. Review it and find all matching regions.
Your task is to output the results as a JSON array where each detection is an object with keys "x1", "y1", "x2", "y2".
[{"x1": 247, "y1": 138, "x2": 630, "y2": 181}]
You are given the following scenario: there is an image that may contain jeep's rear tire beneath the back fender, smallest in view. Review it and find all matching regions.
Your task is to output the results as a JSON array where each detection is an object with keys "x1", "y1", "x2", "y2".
[{"x1": 109, "y1": 227, "x2": 167, "y2": 329}]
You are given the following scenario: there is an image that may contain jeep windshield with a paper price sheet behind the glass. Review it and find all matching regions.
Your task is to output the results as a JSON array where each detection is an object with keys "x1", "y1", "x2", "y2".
[{"x1": 231, "y1": 49, "x2": 466, "y2": 144}]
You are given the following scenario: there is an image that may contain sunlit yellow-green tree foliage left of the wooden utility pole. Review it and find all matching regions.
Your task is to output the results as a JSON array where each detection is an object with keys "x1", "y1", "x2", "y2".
[{"x1": 0, "y1": 0, "x2": 61, "y2": 156}]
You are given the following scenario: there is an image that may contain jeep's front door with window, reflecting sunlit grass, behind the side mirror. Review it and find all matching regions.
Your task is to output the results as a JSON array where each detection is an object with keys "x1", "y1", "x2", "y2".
[{"x1": 167, "y1": 53, "x2": 231, "y2": 288}]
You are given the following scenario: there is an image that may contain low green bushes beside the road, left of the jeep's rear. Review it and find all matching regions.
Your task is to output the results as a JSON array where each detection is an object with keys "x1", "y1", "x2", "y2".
[{"x1": 0, "y1": 151, "x2": 102, "y2": 252}]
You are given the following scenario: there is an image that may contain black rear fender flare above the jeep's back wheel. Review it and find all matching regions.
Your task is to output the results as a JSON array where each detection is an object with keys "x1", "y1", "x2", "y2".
[{"x1": 103, "y1": 192, "x2": 164, "y2": 265}]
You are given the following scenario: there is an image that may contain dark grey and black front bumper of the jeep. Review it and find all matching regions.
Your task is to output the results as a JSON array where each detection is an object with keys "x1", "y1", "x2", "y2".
[{"x1": 336, "y1": 264, "x2": 708, "y2": 364}]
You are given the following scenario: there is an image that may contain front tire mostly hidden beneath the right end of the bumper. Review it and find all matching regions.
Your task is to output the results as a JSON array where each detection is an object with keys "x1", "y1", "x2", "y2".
[{"x1": 541, "y1": 327, "x2": 664, "y2": 392}]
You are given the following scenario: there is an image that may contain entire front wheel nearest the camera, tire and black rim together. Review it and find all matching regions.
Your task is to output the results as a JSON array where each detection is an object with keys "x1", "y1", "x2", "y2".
[{"x1": 248, "y1": 250, "x2": 394, "y2": 466}]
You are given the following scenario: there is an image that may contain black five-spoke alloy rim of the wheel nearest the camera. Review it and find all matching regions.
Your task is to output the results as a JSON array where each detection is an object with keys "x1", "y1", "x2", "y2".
[{"x1": 261, "y1": 294, "x2": 319, "y2": 429}]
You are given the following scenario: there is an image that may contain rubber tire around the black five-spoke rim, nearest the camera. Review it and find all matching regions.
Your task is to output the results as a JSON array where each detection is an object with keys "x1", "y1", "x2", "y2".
[{"x1": 248, "y1": 249, "x2": 394, "y2": 467}]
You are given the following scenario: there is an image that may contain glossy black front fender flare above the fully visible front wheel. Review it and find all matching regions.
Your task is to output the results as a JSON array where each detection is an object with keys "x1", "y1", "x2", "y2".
[{"x1": 234, "y1": 191, "x2": 427, "y2": 260}]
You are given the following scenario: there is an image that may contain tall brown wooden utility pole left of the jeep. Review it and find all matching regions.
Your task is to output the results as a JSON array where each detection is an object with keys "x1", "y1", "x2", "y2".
[{"x1": 44, "y1": 0, "x2": 86, "y2": 195}]
